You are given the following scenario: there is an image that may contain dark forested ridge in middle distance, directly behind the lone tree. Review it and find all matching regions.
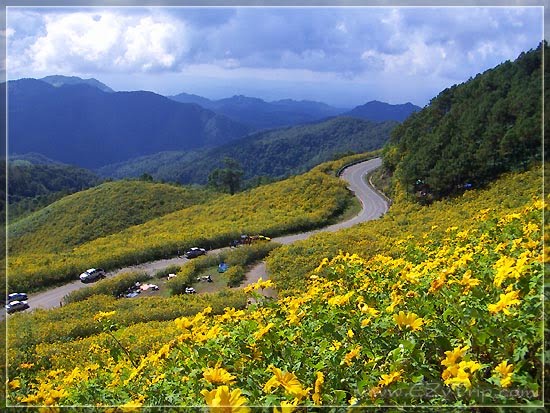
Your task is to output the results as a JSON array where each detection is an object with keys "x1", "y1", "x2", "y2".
[{"x1": 99, "y1": 117, "x2": 397, "y2": 183}]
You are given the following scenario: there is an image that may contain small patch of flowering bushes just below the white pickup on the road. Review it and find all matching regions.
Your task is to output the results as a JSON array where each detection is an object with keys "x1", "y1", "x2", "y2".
[{"x1": 63, "y1": 271, "x2": 151, "y2": 304}]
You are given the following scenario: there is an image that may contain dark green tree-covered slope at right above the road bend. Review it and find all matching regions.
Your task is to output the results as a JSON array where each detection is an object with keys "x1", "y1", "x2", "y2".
[{"x1": 384, "y1": 41, "x2": 548, "y2": 201}]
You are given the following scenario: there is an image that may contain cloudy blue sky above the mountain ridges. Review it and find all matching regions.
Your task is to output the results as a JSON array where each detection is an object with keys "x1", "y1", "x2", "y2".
[{"x1": 4, "y1": 6, "x2": 544, "y2": 108}]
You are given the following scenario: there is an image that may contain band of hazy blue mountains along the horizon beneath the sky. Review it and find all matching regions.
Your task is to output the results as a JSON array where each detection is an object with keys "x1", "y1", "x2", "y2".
[{"x1": 6, "y1": 75, "x2": 420, "y2": 169}]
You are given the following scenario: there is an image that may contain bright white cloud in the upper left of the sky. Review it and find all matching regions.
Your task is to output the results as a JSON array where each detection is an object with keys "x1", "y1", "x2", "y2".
[{"x1": 11, "y1": 11, "x2": 189, "y2": 73}]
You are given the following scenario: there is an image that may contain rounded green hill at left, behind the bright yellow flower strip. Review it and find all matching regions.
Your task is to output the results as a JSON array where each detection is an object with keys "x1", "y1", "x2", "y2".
[{"x1": 8, "y1": 180, "x2": 220, "y2": 255}]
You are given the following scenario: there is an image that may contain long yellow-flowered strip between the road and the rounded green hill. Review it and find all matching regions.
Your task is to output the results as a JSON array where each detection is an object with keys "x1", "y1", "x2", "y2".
[{"x1": 8, "y1": 167, "x2": 352, "y2": 291}]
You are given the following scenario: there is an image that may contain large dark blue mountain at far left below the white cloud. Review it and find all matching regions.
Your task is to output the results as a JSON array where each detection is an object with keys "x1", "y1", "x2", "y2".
[{"x1": 3, "y1": 79, "x2": 248, "y2": 167}]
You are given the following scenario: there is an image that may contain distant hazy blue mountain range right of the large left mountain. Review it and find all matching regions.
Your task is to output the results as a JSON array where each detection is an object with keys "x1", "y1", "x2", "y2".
[{"x1": 170, "y1": 93, "x2": 343, "y2": 130}]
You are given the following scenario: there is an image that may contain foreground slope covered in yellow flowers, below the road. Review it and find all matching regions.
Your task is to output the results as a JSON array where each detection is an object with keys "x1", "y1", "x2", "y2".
[{"x1": 8, "y1": 163, "x2": 544, "y2": 408}]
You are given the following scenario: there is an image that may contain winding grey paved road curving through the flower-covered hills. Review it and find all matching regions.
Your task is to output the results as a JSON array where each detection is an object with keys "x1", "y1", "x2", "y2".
[{"x1": 23, "y1": 158, "x2": 388, "y2": 309}]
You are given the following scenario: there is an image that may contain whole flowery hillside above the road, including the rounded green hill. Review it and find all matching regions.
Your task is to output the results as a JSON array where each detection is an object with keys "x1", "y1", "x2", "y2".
[{"x1": 8, "y1": 166, "x2": 353, "y2": 290}]
